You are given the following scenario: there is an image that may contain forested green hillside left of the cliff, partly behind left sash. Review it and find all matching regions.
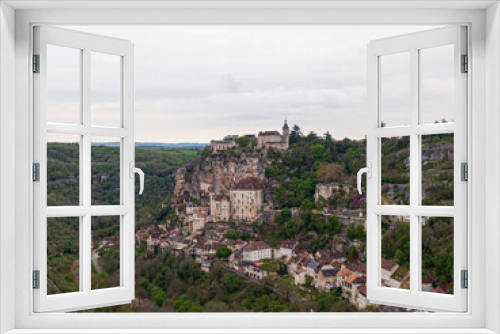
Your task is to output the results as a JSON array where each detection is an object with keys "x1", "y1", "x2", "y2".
[{"x1": 47, "y1": 143, "x2": 200, "y2": 293}]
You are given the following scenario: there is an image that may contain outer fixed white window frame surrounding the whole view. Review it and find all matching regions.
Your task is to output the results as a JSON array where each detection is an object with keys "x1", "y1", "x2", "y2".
[{"x1": 0, "y1": 1, "x2": 500, "y2": 333}]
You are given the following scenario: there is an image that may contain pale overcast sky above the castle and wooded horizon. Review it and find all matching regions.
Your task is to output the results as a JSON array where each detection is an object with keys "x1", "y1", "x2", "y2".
[{"x1": 50, "y1": 26, "x2": 452, "y2": 143}]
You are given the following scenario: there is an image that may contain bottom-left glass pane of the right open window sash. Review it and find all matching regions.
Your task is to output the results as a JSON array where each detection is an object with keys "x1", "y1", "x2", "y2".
[{"x1": 380, "y1": 216, "x2": 410, "y2": 289}]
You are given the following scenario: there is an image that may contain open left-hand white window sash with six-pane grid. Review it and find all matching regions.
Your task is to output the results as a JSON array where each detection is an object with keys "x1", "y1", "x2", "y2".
[{"x1": 33, "y1": 25, "x2": 135, "y2": 312}]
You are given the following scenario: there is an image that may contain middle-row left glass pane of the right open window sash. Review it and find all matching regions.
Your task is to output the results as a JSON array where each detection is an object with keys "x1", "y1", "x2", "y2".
[{"x1": 381, "y1": 136, "x2": 410, "y2": 205}]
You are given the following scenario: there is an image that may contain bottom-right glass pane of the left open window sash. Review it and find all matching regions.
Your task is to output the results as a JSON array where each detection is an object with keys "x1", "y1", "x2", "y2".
[{"x1": 92, "y1": 216, "x2": 120, "y2": 290}]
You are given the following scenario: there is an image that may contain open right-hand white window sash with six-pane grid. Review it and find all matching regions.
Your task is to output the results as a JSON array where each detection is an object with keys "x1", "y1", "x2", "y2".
[{"x1": 366, "y1": 26, "x2": 468, "y2": 312}]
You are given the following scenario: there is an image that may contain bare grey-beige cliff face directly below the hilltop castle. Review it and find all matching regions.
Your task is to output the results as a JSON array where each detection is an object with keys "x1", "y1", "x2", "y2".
[{"x1": 174, "y1": 151, "x2": 271, "y2": 204}]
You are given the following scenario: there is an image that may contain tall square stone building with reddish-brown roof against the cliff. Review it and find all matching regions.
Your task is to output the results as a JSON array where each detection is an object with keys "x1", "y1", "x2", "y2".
[{"x1": 229, "y1": 177, "x2": 263, "y2": 221}]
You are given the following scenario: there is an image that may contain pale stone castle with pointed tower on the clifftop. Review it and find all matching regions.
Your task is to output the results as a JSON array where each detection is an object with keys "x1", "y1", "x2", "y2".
[{"x1": 210, "y1": 120, "x2": 290, "y2": 154}]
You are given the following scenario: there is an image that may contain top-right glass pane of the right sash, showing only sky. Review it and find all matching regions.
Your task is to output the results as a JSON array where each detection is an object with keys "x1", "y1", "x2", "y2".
[{"x1": 420, "y1": 45, "x2": 455, "y2": 124}]
